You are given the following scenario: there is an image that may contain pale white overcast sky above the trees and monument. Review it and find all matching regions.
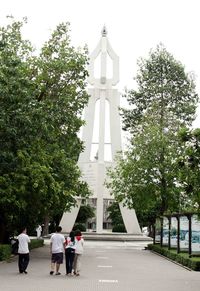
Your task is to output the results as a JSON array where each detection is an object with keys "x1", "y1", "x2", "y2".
[{"x1": 0, "y1": 0, "x2": 200, "y2": 126}]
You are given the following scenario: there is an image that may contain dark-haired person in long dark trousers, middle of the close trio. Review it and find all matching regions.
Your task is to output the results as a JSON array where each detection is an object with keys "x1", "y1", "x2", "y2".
[{"x1": 65, "y1": 231, "x2": 76, "y2": 276}]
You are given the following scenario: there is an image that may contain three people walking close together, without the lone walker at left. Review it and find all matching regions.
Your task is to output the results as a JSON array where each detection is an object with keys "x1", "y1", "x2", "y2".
[{"x1": 50, "y1": 226, "x2": 84, "y2": 276}]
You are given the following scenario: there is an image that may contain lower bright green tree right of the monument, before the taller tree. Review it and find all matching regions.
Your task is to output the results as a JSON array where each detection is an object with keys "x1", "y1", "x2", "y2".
[{"x1": 107, "y1": 116, "x2": 179, "y2": 228}]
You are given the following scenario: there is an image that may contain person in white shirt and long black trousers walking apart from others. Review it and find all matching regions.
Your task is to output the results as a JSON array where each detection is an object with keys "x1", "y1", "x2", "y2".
[{"x1": 17, "y1": 227, "x2": 30, "y2": 274}]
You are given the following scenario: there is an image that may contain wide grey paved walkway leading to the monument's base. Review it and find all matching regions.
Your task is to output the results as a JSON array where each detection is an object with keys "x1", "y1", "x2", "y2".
[{"x1": 0, "y1": 241, "x2": 200, "y2": 291}]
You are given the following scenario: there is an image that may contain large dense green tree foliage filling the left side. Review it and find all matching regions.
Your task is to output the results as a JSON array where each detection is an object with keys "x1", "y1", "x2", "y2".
[{"x1": 0, "y1": 21, "x2": 89, "y2": 241}]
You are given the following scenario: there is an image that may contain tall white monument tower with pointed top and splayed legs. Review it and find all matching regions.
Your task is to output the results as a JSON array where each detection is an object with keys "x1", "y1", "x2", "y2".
[{"x1": 60, "y1": 26, "x2": 141, "y2": 234}]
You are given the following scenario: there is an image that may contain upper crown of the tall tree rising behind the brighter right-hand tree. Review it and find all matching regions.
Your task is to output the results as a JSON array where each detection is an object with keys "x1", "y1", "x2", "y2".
[{"x1": 122, "y1": 44, "x2": 198, "y2": 133}]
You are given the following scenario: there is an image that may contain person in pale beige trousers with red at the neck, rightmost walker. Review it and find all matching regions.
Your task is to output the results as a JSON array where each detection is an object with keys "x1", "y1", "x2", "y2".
[{"x1": 73, "y1": 230, "x2": 84, "y2": 276}]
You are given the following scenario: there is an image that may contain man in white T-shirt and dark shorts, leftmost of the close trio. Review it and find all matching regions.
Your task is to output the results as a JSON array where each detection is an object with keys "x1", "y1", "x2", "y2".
[{"x1": 50, "y1": 226, "x2": 65, "y2": 275}]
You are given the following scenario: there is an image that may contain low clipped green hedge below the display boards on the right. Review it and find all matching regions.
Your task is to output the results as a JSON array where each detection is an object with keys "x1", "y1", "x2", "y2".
[{"x1": 148, "y1": 244, "x2": 200, "y2": 271}]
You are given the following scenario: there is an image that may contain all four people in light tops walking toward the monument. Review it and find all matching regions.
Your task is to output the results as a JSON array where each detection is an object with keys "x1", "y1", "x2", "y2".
[{"x1": 18, "y1": 226, "x2": 84, "y2": 276}]
